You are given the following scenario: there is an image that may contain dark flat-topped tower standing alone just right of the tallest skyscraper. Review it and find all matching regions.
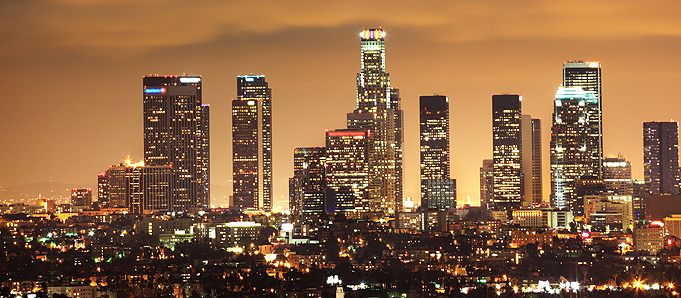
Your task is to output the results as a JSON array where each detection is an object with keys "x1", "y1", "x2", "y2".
[{"x1": 419, "y1": 95, "x2": 456, "y2": 210}]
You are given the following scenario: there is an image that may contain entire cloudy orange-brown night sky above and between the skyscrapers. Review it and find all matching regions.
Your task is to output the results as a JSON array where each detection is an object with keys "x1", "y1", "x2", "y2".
[{"x1": 0, "y1": 0, "x2": 681, "y2": 207}]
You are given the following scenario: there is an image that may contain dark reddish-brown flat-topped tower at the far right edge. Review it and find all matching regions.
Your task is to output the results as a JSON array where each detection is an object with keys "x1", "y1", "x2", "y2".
[{"x1": 643, "y1": 122, "x2": 679, "y2": 195}]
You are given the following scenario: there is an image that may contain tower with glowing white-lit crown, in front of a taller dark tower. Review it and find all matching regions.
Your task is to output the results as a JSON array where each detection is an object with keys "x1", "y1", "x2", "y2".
[{"x1": 551, "y1": 87, "x2": 598, "y2": 212}]
